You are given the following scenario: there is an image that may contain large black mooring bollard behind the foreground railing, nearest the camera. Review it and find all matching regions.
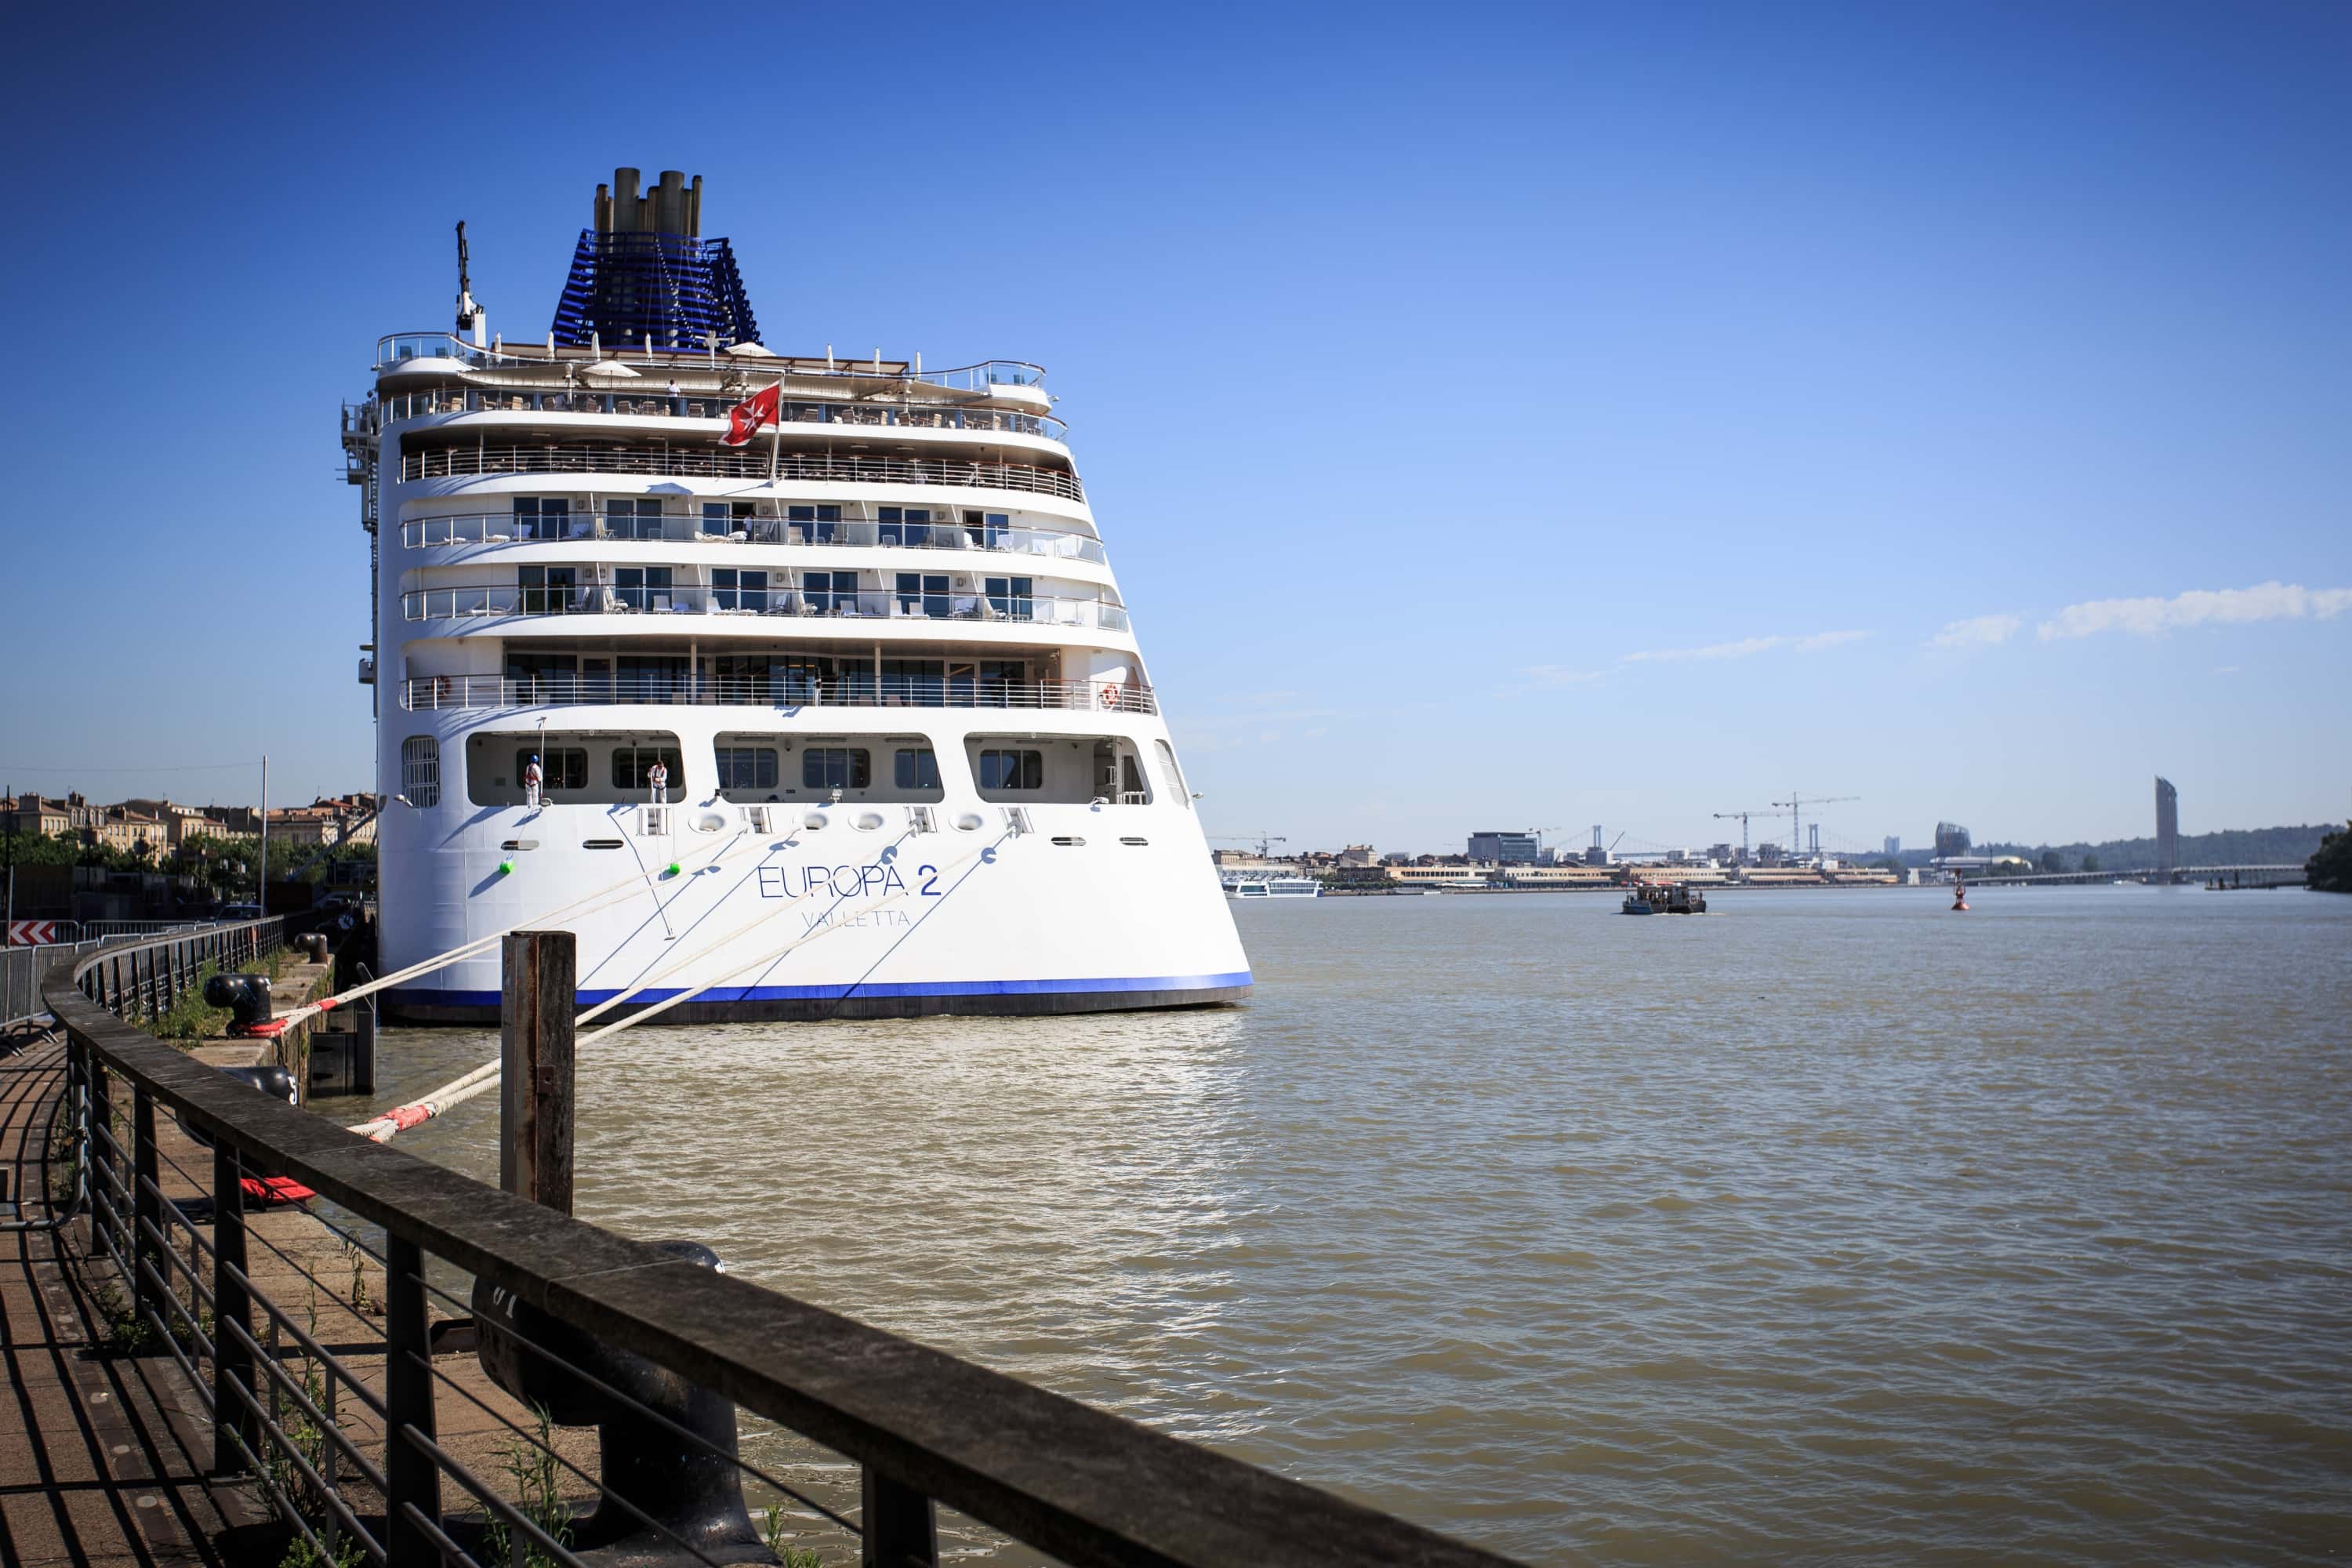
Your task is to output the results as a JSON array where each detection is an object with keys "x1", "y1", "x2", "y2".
[{"x1": 473, "y1": 1241, "x2": 776, "y2": 1568}]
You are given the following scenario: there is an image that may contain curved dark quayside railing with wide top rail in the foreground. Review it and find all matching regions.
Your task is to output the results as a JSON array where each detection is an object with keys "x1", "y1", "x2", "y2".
[{"x1": 42, "y1": 942, "x2": 1503, "y2": 1568}]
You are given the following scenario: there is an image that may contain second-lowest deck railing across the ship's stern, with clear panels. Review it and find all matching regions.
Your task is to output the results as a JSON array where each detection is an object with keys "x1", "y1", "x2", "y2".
[{"x1": 400, "y1": 583, "x2": 1131, "y2": 633}]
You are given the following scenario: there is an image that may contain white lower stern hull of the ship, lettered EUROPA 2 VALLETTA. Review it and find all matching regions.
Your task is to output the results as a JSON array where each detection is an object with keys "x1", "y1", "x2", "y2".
[{"x1": 379, "y1": 706, "x2": 1249, "y2": 1022}]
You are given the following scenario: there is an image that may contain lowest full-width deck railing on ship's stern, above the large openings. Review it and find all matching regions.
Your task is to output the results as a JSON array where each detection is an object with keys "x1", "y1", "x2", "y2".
[{"x1": 400, "y1": 675, "x2": 1160, "y2": 715}]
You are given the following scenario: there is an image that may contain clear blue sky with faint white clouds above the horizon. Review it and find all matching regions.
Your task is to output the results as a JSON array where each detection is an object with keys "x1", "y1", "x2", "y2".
[{"x1": 0, "y1": 5, "x2": 2352, "y2": 848}]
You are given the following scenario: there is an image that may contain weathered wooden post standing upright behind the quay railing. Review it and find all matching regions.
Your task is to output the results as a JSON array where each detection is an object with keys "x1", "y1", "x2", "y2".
[{"x1": 499, "y1": 931, "x2": 579, "y2": 1213}]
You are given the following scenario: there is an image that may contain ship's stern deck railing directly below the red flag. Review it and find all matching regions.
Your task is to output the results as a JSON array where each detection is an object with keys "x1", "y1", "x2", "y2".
[{"x1": 400, "y1": 442, "x2": 1087, "y2": 501}]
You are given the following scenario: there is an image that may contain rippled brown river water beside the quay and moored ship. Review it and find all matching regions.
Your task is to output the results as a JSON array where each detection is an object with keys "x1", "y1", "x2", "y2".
[{"x1": 353, "y1": 886, "x2": 2352, "y2": 1563}]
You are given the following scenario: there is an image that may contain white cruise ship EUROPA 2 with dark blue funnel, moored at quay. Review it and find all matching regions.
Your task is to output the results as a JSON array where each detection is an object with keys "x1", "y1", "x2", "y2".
[{"x1": 343, "y1": 169, "x2": 1249, "y2": 1022}]
